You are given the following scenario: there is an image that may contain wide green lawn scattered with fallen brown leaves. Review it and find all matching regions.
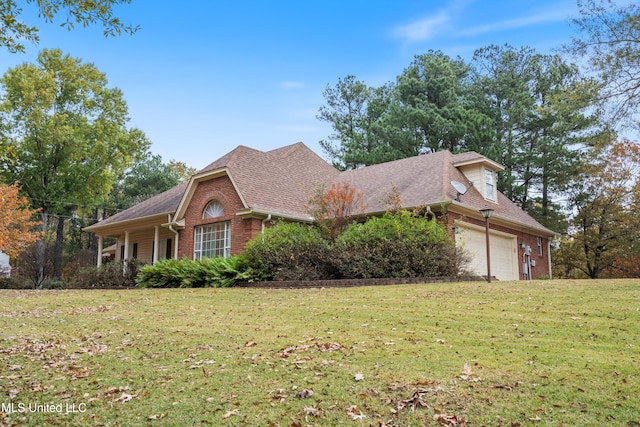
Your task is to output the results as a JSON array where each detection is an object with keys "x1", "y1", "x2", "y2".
[{"x1": 0, "y1": 280, "x2": 640, "y2": 426}]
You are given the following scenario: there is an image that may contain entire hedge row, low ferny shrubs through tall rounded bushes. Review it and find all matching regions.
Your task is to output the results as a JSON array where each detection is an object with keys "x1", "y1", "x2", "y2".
[{"x1": 136, "y1": 212, "x2": 464, "y2": 288}]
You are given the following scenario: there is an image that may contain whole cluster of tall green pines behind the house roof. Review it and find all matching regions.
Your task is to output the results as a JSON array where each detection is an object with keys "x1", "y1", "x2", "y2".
[{"x1": 318, "y1": 45, "x2": 609, "y2": 231}]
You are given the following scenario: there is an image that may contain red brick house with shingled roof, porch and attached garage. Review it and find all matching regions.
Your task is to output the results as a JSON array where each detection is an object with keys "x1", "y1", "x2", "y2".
[{"x1": 84, "y1": 143, "x2": 555, "y2": 280}]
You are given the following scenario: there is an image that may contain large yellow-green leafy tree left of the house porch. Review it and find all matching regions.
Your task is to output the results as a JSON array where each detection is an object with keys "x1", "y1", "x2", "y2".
[{"x1": 0, "y1": 50, "x2": 149, "y2": 286}]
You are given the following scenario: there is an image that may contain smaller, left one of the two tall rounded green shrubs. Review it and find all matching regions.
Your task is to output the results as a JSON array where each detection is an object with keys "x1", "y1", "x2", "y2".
[{"x1": 243, "y1": 222, "x2": 334, "y2": 280}]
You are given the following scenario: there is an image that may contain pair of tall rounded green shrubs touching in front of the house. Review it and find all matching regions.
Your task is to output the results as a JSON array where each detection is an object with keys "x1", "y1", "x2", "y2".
[{"x1": 243, "y1": 211, "x2": 464, "y2": 281}]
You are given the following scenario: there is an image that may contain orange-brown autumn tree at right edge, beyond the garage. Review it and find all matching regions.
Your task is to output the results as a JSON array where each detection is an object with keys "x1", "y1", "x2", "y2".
[{"x1": 561, "y1": 140, "x2": 640, "y2": 279}]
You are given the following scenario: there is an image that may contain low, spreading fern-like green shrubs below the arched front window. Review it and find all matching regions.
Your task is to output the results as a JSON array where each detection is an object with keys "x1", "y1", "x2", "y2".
[{"x1": 135, "y1": 256, "x2": 253, "y2": 288}]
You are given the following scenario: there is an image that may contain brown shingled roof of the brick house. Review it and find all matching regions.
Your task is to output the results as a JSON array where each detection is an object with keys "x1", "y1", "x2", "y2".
[{"x1": 86, "y1": 142, "x2": 553, "y2": 234}]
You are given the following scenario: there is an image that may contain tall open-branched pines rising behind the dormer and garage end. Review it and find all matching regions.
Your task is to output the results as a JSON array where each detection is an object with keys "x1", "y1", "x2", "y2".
[{"x1": 472, "y1": 45, "x2": 608, "y2": 229}]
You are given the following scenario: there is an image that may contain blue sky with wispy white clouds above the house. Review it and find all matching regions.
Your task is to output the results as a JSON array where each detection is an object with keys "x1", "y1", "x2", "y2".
[{"x1": 0, "y1": 0, "x2": 577, "y2": 169}]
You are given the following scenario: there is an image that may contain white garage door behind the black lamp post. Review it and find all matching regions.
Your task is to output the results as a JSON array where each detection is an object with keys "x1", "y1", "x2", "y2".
[{"x1": 456, "y1": 223, "x2": 519, "y2": 280}]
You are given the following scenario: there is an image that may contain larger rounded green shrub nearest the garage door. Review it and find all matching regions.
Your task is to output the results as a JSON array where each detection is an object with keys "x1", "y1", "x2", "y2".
[{"x1": 332, "y1": 211, "x2": 462, "y2": 279}]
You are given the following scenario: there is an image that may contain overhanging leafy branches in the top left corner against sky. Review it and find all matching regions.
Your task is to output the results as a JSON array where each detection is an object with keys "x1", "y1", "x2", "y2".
[{"x1": 0, "y1": 0, "x2": 139, "y2": 53}]
